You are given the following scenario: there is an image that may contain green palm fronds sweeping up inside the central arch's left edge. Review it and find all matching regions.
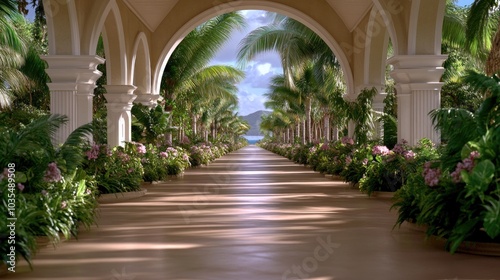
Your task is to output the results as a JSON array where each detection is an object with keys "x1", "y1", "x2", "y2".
[{"x1": 161, "y1": 13, "x2": 244, "y2": 140}]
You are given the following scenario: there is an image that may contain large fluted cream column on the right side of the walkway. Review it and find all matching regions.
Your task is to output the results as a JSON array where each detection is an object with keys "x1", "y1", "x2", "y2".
[{"x1": 388, "y1": 55, "x2": 447, "y2": 145}]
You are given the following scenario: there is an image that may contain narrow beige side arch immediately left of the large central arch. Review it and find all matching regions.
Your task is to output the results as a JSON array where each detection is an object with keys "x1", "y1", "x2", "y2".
[{"x1": 130, "y1": 32, "x2": 151, "y2": 94}]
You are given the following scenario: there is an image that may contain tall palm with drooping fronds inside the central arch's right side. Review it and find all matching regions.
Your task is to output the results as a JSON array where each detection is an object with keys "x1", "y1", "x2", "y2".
[{"x1": 238, "y1": 15, "x2": 350, "y2": 143}]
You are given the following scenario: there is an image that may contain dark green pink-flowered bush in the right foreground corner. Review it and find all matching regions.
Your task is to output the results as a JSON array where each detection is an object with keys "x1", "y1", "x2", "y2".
[{"x1": 393, "y1": 127, "x2": 500, "y2": 252}]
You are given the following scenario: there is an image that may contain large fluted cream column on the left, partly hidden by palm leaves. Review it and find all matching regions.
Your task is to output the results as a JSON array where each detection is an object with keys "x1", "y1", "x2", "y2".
[{"x1": 42, "y1": 55, "x2": 104, "y2": 144}]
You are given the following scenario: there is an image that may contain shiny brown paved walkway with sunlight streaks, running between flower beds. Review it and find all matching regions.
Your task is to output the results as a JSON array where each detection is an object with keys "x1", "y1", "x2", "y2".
[{"x1": 7, "y1": 146, "x2": 500, "y2": 280}]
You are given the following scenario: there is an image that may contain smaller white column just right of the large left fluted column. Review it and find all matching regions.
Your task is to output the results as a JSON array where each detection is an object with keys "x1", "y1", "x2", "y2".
[{"x1": 104, "y1": 85, "x2": 136, "y2": 147}]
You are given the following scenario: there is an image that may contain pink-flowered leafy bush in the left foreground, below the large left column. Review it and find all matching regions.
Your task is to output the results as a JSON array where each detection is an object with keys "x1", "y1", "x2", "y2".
[{"x1": 0, "y1": 113, "x2": 96, "y2": 268}]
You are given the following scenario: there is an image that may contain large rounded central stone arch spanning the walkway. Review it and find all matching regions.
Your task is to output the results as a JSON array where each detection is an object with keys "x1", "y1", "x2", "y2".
[{"x1": 153, "y1": 1, "x2": 354, "y2": 93}]
